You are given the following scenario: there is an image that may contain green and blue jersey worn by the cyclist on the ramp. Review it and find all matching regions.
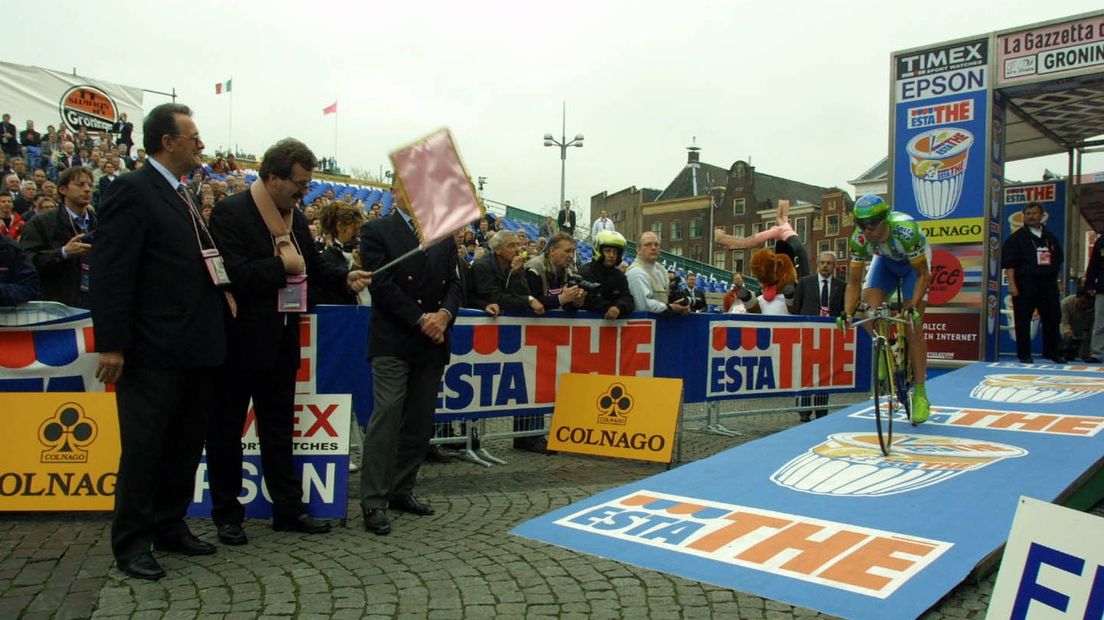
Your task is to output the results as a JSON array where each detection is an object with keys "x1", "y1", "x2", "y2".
[{"x1": 851, "y1": 211, "x2": 932, "y2": 299}]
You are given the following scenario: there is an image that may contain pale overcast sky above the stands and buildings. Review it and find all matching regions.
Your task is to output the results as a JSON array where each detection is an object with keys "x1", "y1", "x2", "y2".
[{"x1": 3, "y1": 0, "x2": 1104, "y2": 219}]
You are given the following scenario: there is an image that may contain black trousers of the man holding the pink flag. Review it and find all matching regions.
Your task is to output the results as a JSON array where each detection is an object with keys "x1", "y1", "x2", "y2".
[{"x1": 206, "y1": 365, "x2": 305, "y2": 525}]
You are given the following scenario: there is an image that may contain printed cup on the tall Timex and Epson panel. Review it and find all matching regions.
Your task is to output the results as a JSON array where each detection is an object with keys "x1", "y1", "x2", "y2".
[{"x1": 906, "y1": 127, "x2": 974, "y2": 220}]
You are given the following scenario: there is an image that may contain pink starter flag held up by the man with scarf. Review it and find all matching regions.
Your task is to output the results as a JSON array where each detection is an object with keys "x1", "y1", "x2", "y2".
[{"x1": 391, "y1": 129, "x2": 484, "y2": 247}]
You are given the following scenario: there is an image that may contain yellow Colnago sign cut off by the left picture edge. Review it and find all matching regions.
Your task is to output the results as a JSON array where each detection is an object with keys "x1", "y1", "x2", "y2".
[{"x1": 0, "y1": 392, "x2": 119, "y2": 511}]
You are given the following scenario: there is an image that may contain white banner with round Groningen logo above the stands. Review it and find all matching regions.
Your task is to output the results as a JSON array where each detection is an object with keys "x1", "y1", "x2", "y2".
[{"x1": 0, "y1": 63, "x2": 145, "y2": 135}]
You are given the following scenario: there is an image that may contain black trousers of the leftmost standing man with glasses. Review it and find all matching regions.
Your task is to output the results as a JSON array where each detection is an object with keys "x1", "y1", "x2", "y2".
[{"x1": 112, "y1": 366, "x2": 213, "y2": 559}]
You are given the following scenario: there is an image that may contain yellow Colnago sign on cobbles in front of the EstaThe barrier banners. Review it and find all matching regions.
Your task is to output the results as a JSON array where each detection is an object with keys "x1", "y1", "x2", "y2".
[{"x1": 549, "y1": 374, "x2": 682, "y2": 463}]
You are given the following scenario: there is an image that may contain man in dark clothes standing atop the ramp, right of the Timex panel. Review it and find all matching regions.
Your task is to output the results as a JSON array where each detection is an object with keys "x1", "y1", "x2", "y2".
[{"x1": 1000, "y1": 202, "x2": 1065, "y2": 364}]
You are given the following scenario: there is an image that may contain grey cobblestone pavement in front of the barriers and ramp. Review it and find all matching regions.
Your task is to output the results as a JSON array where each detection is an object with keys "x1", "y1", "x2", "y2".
[{"x1": 0, "y1": 394, "x2": 1104, "y2": 620}]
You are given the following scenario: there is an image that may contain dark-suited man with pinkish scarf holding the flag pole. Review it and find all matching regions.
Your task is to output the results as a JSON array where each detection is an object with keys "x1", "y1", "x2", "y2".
[{"x1": 206, "y1": 138, "x2": 373, "y2": 545}]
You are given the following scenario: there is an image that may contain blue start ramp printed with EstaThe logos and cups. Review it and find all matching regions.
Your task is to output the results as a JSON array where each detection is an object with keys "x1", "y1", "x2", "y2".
[{"x1": 513, "y1": 363, "x2": 1104, "y2": 619}]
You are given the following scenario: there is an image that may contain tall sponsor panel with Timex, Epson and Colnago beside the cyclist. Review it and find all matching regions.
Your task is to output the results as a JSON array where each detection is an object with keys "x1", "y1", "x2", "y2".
[{"x1": 891, "y1": 38, "x2": 992, "y2": 361}]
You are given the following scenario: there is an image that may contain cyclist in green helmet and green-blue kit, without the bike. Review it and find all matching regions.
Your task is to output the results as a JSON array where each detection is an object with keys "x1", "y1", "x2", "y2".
[{"x1": 837, "y1": 194, "x2": 932, "y2": 424}]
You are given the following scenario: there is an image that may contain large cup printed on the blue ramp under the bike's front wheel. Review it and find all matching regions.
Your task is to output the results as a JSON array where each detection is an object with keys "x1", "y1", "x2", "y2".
[{"x1": 771, "y1": 432, "x2": 1028, "y2": 498}]
